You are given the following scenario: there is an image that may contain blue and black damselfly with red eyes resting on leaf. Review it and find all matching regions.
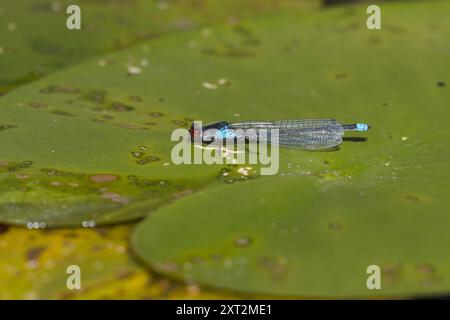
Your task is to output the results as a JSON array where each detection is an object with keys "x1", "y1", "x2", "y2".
[{"x1": 189, "y1": 119, "x2": 369, "y2": 150}]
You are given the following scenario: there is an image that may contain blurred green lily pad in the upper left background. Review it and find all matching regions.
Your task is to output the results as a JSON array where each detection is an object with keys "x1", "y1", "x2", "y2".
[{"x1": 0, "y1": 0, "x2": 316, "y2": 94}]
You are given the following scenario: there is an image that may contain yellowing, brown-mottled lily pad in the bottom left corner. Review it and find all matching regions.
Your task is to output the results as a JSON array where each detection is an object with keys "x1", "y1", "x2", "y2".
[{"x1": 0, "y1": 225, "x2": 251, "y2": 299}]
